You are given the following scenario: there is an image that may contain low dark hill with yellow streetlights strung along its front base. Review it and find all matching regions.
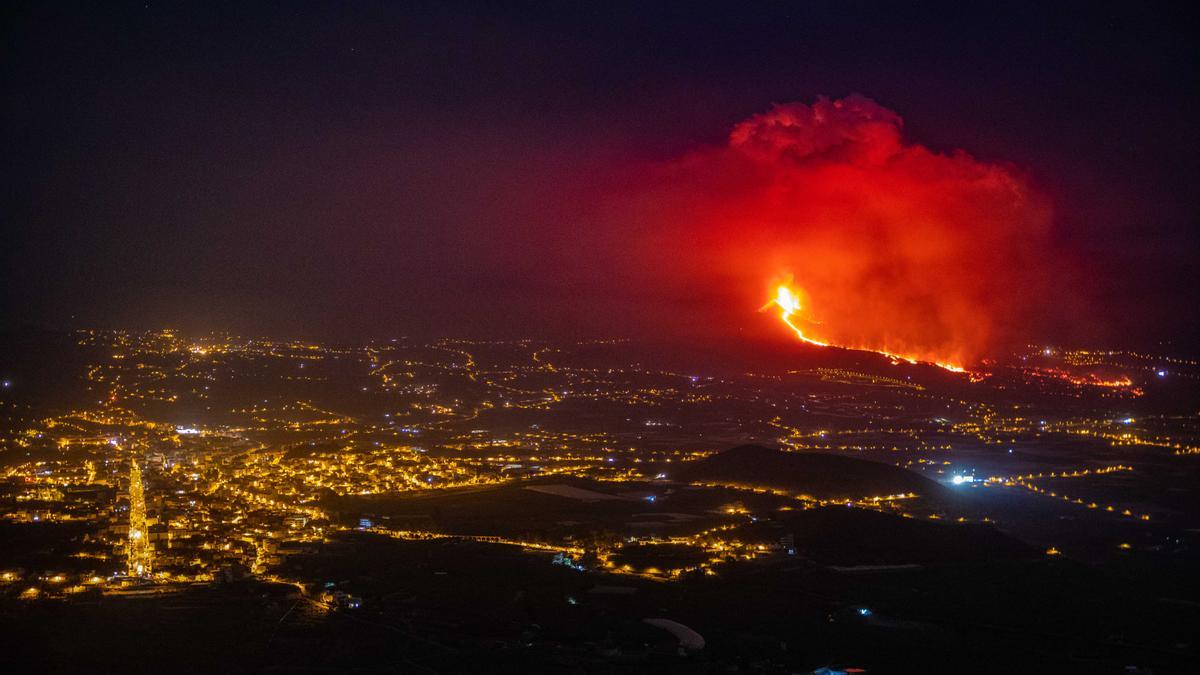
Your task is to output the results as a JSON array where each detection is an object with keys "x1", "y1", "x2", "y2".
[{"x1": 676, "y1": 446, "x2": 948, "y2": 498}]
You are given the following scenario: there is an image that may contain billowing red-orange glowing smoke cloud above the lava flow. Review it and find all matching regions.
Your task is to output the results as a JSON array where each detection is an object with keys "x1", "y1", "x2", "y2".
[{"x1": 644, "y1": 96, "x2": 1064, "y2": 365}]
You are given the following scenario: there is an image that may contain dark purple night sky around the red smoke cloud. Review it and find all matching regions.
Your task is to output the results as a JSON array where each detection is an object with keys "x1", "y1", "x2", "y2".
[{"x1": 0, "y1": 1, "x2": 1200, "y2": 351}]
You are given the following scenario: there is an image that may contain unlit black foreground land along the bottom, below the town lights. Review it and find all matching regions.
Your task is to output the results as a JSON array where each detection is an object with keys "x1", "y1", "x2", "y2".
[{"x1": 0, "y1": 521, "x2": 1200, "y2": 673}]
